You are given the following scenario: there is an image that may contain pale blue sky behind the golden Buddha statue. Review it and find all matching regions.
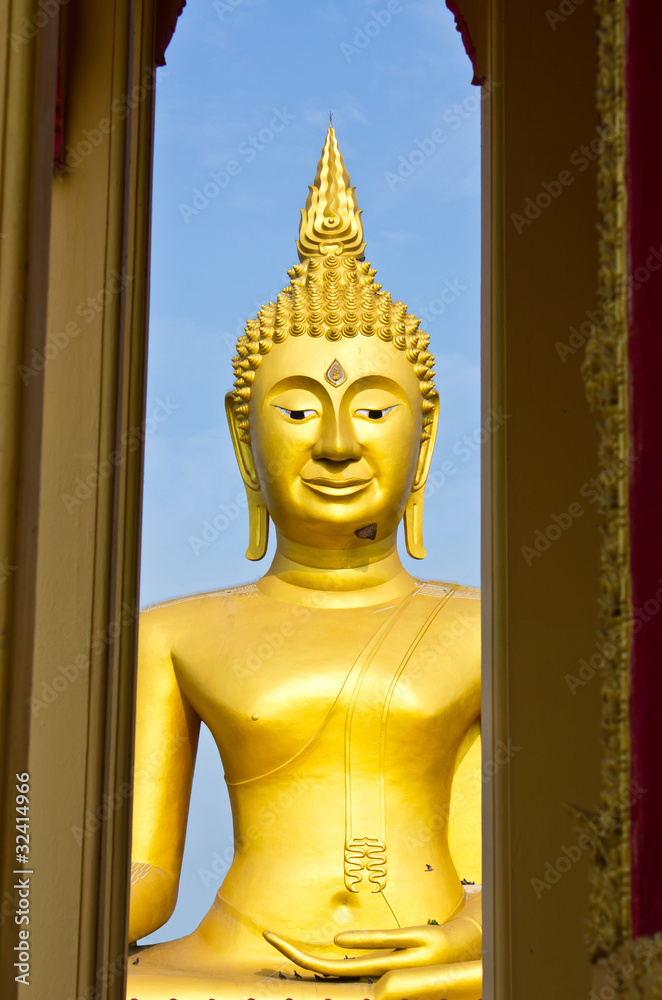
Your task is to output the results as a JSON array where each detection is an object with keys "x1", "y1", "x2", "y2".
[{"x1": 141, "y1": 0, "x2": 481, "y2": 941}]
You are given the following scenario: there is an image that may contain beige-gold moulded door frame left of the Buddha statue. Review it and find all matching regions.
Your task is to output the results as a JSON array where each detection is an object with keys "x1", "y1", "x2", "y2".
[{"x1": 2, "y1": 0, "x2": 155, "y2": 1000}]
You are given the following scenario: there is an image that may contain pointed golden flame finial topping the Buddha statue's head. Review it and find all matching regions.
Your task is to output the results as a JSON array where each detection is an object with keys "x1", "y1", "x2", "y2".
[{"x1": 297, "y1": 125, "x2": 365, "y2": 261}]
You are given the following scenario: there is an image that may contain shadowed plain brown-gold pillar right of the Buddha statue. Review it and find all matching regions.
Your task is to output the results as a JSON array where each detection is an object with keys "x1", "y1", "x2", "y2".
[{"x1": 484, "y1": 0, "x2": 600, "y2": 1000}]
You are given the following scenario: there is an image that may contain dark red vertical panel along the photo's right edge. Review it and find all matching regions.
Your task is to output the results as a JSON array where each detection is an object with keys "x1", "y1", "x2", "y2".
[{"x1": 626, "y1": 0, "x2": 662, "y2": 937}]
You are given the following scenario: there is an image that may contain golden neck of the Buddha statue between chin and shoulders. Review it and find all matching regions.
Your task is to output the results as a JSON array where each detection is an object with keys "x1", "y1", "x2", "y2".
[{"x1": 258, "y1": 532, "x2": 416, "y2": 608}]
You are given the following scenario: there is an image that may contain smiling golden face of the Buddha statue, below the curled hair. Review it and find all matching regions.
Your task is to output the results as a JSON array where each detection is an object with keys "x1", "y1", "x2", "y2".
[{"x1": 231, "y1": 335, "x2": 432, "y2": 549}]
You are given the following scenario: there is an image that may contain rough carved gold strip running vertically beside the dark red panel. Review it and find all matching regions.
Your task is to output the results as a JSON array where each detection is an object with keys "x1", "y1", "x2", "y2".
[{"x1": 582, "y1": 0, "x2": 639, "y2": 960}]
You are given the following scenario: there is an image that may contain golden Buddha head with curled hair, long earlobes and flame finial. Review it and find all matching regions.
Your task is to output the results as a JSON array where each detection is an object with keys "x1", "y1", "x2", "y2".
[{"x1": 226, "y1": 127, "x2": 438, "y2": 559}]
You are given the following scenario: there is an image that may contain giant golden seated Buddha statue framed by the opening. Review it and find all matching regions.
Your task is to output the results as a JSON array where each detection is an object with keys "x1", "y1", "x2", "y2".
[{"x1": 127, "y1": 128, "x2": 481, "y2": 1000}]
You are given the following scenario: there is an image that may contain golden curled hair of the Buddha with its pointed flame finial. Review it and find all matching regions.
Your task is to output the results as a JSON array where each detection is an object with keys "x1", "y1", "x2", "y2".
[{"x1": 233, "y1": 127, "x2": 436, "y2": 441}]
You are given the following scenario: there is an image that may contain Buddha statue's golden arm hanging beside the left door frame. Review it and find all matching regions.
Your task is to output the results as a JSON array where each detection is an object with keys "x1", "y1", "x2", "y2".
[{"x1": 129, "y1": 609, "x2": 200, "y2": 941}]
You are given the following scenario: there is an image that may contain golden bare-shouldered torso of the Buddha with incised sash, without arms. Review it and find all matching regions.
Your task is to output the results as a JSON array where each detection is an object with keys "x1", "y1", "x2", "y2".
[{"x1": 132, "y1": 584, "x2": 480, "y2": 976}]
